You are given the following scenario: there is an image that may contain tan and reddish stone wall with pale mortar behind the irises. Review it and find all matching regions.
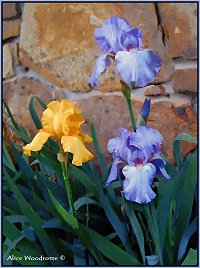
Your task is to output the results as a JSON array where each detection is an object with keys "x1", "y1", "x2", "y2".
[{"x1": 3, "y1": 2, "x2": 197, "y2": 159}]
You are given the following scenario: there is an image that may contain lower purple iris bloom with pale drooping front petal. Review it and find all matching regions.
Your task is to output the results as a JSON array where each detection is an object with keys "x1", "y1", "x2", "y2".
[{"x1": 107, "y1": 126, "x2": 169, "y2": 204}]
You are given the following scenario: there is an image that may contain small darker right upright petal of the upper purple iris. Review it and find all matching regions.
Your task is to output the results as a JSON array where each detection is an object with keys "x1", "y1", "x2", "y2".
[{"x1": 121, "y1": 28, "x2": 143, "y2": 51}]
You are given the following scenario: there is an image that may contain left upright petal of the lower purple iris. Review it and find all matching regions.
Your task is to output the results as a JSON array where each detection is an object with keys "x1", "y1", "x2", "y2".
[{"x1": 107, "y1": 128, "x2": 131, "y2": 163}]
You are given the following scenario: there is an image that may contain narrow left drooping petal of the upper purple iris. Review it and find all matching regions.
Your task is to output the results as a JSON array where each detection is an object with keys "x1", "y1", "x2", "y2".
[{"x1": 89, "y1": 55, "x2": 111, "y2": 88}]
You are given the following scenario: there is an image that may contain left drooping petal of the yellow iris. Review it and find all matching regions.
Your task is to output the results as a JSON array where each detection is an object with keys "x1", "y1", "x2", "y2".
[{"x1": 23, "y1": 130, "x2": 52, "y2": 156}]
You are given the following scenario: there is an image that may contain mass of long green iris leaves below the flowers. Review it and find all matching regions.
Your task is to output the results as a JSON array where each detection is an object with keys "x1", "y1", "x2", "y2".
[{"x1": 2, "y1": 97, "x2": 198, "y2": 266}]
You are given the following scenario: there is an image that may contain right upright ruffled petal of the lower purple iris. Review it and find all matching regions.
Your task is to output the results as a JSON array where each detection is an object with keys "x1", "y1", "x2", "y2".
[{"x1": 129, "y1": 126, "x2": 163, "y2": 160}]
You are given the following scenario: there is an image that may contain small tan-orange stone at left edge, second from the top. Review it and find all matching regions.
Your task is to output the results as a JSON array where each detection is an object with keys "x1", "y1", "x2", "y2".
[{"x1": 3, "y1": 20, "x2": 21, "y2": 40}]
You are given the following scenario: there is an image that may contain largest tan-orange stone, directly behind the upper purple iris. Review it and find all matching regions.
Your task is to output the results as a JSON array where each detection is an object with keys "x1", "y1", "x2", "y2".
[{"x1": 20, "y1": 3, "x2": 173, "y2": 92}]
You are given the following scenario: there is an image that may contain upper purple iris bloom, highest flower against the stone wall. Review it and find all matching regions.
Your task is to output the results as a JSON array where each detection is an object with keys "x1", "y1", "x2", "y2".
[{"x1": 89, "y1": 16, "x2": 161, "y2": 87}]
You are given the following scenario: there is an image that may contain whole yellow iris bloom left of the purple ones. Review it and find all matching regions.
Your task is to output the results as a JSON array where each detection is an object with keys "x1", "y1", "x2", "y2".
[{"x1": 23, "y1": 100, "x2": 93, "y2": 166}]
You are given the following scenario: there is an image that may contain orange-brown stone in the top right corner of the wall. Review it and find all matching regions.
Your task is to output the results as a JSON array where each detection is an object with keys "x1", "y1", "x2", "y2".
[{"x1": 158, "y1": 3, "x2": 198, "y2": 59}]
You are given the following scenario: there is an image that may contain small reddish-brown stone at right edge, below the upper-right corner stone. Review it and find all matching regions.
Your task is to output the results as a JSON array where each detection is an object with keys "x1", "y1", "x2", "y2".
[{"x1": 173, "y1": 68, "x2": 197, "y2": 94}]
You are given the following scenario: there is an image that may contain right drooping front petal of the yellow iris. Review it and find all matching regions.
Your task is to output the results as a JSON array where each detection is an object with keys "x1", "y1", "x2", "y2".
[{"x1": 61, "y1": 136, "x2": 93, "y2": 166}]
